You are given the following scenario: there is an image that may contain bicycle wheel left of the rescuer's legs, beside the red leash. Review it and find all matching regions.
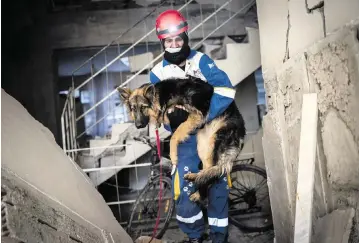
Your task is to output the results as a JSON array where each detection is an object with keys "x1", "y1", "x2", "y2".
[{"x1": 127, "y1": 175, "x2": 174, "y2": 240}]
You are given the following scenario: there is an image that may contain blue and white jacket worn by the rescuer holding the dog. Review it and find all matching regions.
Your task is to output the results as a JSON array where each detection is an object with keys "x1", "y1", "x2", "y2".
[{"x1": 150, "y1": 50, "x2": 236, "y2": 131}]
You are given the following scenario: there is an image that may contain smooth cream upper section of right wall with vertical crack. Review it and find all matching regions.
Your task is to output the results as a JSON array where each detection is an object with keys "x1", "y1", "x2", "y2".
[{"x1": 257, "y1": 0, "x2": 359, "y2": 70}]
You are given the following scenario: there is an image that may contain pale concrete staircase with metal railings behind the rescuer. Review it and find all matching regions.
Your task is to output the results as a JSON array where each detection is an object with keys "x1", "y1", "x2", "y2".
[{"x1": 61, "y1": 0, "x2": 261, "y2": 186}]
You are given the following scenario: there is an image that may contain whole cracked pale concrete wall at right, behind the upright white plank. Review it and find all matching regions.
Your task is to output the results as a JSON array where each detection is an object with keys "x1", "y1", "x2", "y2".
[{"x1": 257, "y1": 0, "x2": 359, "y2": 243}]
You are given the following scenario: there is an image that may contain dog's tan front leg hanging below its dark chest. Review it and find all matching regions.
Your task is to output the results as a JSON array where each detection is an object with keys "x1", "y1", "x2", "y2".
[{"x1": 170, "y1": 113, "x2": 203, "y2": 165}]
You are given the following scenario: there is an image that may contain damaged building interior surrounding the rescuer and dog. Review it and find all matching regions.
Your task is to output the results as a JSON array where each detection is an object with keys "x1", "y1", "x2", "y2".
[{"x1": 1, "y1": 0, "x2": 359, "y2": 243}]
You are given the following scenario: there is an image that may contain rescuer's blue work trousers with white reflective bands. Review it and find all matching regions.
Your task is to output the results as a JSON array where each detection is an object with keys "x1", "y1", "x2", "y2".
[{"x1": 172, "y1": 135, "x2": 229, "y2": 243}]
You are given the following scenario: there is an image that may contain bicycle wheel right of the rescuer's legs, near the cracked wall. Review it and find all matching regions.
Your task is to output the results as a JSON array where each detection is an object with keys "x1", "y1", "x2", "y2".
[{"x1": 229, "y1": 164, "x2": 273, "y2": 232}]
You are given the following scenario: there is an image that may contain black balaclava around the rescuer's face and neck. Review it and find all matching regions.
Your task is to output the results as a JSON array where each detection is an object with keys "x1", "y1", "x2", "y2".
[{"x1": 162, "y1": 32, "x2": 191, "y2": 65}]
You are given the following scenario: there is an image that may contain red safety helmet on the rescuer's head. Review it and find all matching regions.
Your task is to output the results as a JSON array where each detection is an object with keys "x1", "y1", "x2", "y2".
[{"x1": 156, "y1": 9, "x2": 188, "y2": 40}]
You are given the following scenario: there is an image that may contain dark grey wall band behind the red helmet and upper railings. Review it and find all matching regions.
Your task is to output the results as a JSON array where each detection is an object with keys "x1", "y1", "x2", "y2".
[{"x1": 49, "y1": 4, "x2": 253, "y2": 48}]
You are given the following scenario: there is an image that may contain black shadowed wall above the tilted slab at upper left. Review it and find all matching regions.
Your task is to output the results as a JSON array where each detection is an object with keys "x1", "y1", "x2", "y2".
[{"x1": 1, "y1": 0, "x2": 60, "y2": 142}]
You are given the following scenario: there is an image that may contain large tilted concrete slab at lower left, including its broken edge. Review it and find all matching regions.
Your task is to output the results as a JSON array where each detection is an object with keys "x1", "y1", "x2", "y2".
[{"x1": 1, "y1": 90, "x2": 132, "y2": 243}]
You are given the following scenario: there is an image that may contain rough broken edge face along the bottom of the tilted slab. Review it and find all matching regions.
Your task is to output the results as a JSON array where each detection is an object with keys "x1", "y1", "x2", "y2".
[{"x1": 1, "y1": 170, "x2": 107, "y2": 243}]
